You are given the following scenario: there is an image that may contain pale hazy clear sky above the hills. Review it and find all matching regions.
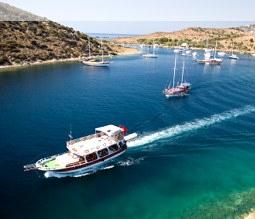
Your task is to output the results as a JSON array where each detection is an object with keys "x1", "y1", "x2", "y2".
[{"x1": 0, "y1": 0, "x2": 255, "y2": 34}]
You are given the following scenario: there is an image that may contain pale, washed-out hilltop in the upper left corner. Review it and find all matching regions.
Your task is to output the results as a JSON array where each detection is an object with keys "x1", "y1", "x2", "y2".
[{"x1": 0, "y1": 2, "x2": 47, "y2": 21}]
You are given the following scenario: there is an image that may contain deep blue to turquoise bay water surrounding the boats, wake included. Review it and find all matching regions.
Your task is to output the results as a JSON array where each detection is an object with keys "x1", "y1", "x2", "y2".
[{"x1": 0, "y1": 49, "x2": 255, "y2": 219}]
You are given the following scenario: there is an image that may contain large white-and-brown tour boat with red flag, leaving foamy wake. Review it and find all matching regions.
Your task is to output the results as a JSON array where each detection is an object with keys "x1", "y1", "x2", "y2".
[{"x1": 24, "y1": 125, "x2": 137, "y2": 173}]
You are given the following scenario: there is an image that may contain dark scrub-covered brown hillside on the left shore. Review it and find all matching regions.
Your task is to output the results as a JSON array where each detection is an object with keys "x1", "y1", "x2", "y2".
[{"x1": 0, "y1": 21, "x2": 115, "y2": 66}]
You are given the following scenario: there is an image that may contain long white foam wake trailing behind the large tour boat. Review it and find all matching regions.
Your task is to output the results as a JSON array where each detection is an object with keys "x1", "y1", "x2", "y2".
[{"x1": 128, "y1": 106, "x2": 255, "y2": 147}]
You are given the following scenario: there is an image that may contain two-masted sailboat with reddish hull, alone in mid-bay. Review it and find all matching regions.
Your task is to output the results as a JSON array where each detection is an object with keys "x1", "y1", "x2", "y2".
[{"x1": 163, "y1": 58, "x2": 191, "y2": 98}]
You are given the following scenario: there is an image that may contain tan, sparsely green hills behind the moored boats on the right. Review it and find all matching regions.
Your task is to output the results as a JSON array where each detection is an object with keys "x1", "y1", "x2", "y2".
[{"x1": 115, "y1": 25, "x2": 255, "y2": 53}]
